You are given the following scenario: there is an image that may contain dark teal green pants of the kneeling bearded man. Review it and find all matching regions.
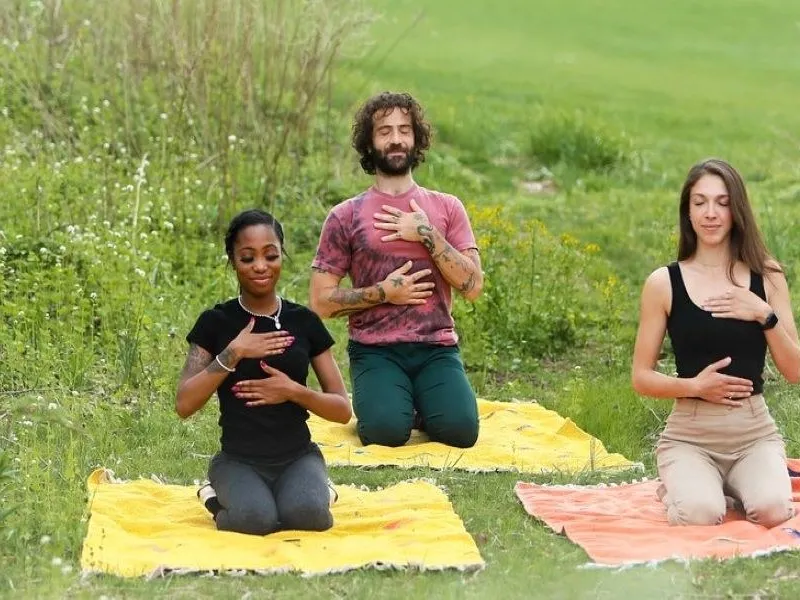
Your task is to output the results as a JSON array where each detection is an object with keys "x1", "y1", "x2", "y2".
[{"x1": 347, "y1": 341, "x2": 478, "y2": 448}]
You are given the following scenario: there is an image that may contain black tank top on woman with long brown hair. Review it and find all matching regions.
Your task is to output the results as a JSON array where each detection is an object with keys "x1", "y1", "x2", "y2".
[{"x1": 667, "y1": 262, "x2": 767, "y2": 394}]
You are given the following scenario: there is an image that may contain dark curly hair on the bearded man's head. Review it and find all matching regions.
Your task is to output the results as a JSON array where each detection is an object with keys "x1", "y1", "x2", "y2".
[{"x1": 353, "y1": 92, "x2": 431, "y2": 175}]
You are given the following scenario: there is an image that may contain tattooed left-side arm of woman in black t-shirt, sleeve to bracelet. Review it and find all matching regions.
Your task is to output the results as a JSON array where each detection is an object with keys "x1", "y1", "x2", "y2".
[{"x1": 175, "y1": 344, "x2": 235, "y2": 419}]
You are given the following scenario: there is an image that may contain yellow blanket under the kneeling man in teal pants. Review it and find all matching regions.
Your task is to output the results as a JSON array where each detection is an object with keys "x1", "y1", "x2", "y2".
[{"x1": 309, "y1": 400, "x2": 642, "y2": 473}]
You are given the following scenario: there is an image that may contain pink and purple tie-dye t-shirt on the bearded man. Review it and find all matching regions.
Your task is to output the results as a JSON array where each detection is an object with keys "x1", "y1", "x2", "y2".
[{"x1": 312, "y1": 185, "x2": 477, "y2": 346}]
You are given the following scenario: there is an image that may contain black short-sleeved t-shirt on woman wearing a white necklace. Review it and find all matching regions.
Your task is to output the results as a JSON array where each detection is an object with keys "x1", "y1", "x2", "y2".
[{"x1": 186, "y1": 298, "x2": 334, "y2": 461}]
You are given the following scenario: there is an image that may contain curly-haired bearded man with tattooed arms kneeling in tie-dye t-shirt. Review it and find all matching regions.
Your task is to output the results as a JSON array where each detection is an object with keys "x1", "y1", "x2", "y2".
[{"x1": 310, "y1": 92, "x2": 483, "y2": 448}]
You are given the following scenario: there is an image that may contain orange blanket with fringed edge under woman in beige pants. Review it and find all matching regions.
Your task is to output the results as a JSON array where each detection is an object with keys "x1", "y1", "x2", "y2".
[{"x1": 515, "y1": 459, "x2": 800, "y2": 566}]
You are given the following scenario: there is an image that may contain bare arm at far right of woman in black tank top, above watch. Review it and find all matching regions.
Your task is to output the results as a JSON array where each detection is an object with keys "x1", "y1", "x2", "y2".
[{"x1": 759, "y1": 273, "x2": 800, "y2": 383}]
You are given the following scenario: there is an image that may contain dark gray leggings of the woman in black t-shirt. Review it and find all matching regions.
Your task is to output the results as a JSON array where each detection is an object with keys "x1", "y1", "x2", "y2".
[{"x1": 208, "y1": 444, "x2": 333, "y2": 535}]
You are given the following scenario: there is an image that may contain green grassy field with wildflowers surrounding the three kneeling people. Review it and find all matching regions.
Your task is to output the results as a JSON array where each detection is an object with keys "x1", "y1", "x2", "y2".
[{"x1": 0, "y1": 0, "x2": 800, "y2": 598}]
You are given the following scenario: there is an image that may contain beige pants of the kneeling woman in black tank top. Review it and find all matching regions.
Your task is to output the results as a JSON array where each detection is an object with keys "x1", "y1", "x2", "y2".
[{"x1": 656, "y1": 395, "x2": 794, "y2": 527}]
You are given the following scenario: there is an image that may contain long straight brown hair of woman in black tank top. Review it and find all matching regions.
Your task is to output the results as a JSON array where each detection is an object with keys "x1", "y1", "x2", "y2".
[{"x1": 678, "y1": 158, "x2": 781, "y2": 283}]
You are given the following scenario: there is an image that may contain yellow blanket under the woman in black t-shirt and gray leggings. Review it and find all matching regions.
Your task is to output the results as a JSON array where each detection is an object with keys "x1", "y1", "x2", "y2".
[{"x1": 81, "y1": 469, "x2": 484, "y2": 577}]
